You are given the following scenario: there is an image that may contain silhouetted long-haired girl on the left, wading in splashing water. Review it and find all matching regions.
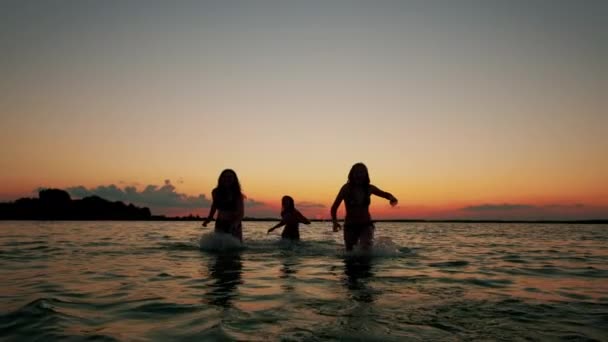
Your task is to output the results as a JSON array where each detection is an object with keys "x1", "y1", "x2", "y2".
[{"x1": 203, "y1": 169, "x2": 245, "y2": 242}]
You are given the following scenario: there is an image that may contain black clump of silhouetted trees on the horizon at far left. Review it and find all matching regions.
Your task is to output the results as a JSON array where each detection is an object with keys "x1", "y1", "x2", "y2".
[{"x1": 0, "y1": 189, "x2": 152, "y2": 220}]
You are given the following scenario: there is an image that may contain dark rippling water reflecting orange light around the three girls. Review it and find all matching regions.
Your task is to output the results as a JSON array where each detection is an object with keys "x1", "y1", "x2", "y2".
[{"x1": 0, "y1": 221, "x2": 608, "y2": 341}]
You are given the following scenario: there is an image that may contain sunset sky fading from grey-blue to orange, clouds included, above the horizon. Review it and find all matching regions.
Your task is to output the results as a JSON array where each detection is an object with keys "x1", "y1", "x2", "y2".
[{"x1": 0, "y1": 0, "x2": 608, "y2": 219}]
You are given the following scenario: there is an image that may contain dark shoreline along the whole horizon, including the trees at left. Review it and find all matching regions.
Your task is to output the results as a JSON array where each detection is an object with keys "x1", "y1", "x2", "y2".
[{"x1": 0, "y1": 189, "x2": 608, "y2": 224}]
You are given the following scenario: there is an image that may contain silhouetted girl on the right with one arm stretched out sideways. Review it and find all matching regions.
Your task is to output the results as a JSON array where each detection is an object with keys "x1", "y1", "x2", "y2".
[{"x1": 331, "y1": 163, "x2": 397, "y2": 251}]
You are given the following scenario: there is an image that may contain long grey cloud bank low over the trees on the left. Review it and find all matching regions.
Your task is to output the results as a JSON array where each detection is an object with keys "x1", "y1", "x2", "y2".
[{"x1": 65, "y1": 179, "x2": 211, "y2": 209}]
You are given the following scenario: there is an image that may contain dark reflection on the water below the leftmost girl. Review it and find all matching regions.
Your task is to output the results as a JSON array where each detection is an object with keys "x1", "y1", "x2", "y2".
[{"x1": 207, "y1": 253, "x2": 243, "y2": 308}]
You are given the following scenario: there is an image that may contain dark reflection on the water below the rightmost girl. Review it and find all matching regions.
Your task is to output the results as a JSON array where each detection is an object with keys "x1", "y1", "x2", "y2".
[{"x1": 344, "y1": 255, "x2": 374, "y2": 303}]
